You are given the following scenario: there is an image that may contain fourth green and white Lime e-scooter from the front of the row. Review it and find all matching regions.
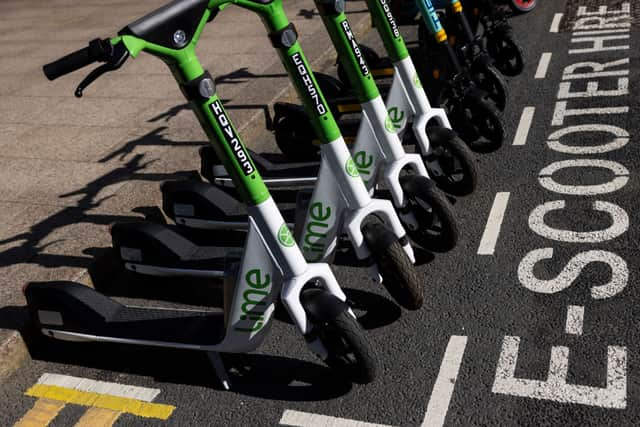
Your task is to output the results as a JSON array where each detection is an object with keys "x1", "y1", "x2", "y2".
[{"x1": 273, "y1": 0, "x2": 477, "y2": 195}]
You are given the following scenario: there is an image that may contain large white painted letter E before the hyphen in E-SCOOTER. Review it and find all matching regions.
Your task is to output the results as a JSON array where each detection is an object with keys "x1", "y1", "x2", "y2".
[{"x1": 492, "y1": 336, "x2": 627, "y2": 409}]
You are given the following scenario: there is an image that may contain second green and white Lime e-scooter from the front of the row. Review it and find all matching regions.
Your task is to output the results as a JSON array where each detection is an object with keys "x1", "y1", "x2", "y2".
[{"x1": 112, "y1": 0, "x2": 424, "y2": 309}]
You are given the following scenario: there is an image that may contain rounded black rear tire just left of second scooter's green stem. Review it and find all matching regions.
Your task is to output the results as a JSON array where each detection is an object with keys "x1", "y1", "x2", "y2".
[{"x1": 273, "y1": 106, "x2": 320, "y2": 162}]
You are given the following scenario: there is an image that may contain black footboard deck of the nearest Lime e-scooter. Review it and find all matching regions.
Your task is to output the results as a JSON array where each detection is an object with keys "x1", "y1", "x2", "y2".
[{"x1": 25, "y1": 281, "x2": 225, "y2": 345}]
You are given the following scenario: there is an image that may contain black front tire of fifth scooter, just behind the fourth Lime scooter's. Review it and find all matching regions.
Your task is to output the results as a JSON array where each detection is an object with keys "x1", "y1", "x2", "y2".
[{"x1": 452, "y1": 95, "x2": 505, "y2": 153}]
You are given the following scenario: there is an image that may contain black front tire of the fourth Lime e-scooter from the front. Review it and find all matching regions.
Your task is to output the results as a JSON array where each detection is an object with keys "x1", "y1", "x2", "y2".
[{"x1": 422, "y1": 126, "x2": 478, "y2": 196}]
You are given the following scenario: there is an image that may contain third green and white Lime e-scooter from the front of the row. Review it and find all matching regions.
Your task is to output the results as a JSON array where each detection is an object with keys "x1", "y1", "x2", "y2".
[{"x1": 170, "y1": 0, "x2": 458, "y2": 259}]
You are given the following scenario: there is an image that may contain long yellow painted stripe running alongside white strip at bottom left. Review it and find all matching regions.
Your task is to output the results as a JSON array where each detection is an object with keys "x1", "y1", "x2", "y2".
[{"x1": 25, "y1": 384, "x2": 176, "y2": 420}]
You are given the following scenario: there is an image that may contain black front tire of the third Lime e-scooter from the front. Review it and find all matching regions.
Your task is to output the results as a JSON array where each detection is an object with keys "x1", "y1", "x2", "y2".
[{"x1": 401, "y1": 175, "x2": 460, "y2": 252}]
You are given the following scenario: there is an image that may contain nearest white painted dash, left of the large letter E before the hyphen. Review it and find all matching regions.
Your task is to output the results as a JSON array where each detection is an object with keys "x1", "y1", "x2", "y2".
[{"x1": 422, "y1": 335, "x2": 467, "y2": 427}]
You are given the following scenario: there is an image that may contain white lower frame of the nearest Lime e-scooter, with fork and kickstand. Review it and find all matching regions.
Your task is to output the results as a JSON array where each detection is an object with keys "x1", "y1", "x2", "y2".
[{"x1": 38, "y1": 198, "x2": 355, "y2": 389}]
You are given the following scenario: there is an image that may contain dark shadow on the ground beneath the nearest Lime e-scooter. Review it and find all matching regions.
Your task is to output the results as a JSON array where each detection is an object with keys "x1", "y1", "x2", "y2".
[{"x1": 0, "y1": 306, "x2": 351, "y2": 401}]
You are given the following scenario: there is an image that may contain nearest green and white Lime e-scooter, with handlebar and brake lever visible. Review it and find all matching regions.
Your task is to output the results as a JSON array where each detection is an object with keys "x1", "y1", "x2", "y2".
[{"x1": 25, "y1": 0, "x2": 378, "y2": 388}]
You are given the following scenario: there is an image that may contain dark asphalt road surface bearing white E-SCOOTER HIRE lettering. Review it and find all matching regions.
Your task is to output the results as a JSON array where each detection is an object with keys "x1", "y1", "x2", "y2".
[{"x1": 0, "y1": 0, "x2": 640, "y2": 426}]
